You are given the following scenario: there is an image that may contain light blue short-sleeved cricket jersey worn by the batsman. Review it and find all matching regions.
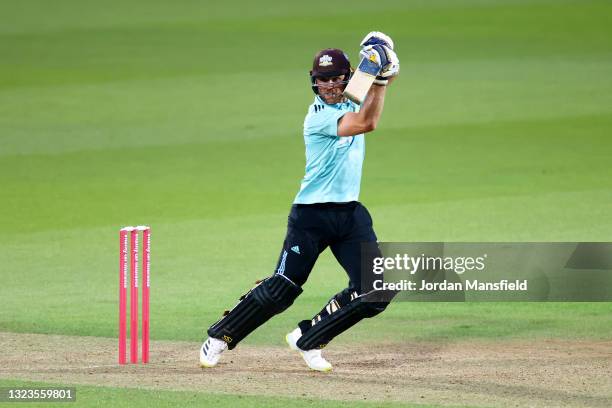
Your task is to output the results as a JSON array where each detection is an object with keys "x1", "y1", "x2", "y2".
[{"x1": 293, "y1": 95, "x2": 365, "y2": 204}]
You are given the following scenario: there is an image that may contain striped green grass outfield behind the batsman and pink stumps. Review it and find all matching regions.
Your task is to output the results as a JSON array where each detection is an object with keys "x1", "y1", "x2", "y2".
[{"x1": 0, "y1": 0, "x2": 612, "y2": 406}]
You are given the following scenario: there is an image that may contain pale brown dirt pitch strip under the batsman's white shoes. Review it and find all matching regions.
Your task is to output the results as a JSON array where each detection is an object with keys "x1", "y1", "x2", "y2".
[{"x1": 0, "y1": 332, "x2": 612, "y2": 407}]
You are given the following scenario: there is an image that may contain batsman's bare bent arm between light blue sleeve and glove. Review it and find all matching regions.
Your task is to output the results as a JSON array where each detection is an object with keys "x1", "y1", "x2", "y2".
[{"x1": 338, "y1": 77, "x2": 395, "y2": 136}]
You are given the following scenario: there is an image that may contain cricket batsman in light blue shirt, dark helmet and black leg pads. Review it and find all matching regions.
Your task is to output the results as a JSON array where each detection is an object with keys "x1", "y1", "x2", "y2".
[{"x1": 200, "y1": 31, "x2": 399, "y2": 371}]
